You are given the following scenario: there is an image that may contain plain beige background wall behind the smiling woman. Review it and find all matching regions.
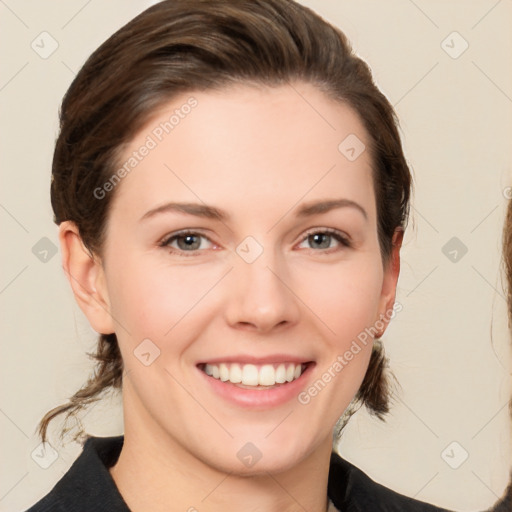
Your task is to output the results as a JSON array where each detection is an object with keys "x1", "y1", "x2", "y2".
[{"x1": 0, "y1": 0, "x2": 512, "y2": 511}]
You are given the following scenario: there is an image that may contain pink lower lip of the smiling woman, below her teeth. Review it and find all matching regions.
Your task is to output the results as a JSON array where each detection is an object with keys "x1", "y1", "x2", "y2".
[{"x1": 197, "y1": 363, "x2": 315, "y2": 409}]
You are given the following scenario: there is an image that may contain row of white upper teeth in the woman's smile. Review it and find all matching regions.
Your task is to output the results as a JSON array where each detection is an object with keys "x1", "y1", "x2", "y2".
[{"x1": 204, "y1": 363, "x2": 303, "y2": 386}]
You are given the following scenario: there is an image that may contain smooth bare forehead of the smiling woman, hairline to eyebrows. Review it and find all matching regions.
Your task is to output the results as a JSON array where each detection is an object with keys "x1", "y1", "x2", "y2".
[{"x1": 107, "y1": 83, "x2": 375, "y2": 222}]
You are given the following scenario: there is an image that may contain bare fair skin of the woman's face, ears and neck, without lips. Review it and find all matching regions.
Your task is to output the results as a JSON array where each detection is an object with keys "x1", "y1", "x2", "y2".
[{"x1": 60, "y1": 83, "x2": 401, "y2": 512}]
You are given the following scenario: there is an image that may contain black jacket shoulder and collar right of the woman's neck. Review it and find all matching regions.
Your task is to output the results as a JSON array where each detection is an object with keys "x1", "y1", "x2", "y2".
[{"x1": 328, "y1": 452, "x2": 449, "y2": 512}]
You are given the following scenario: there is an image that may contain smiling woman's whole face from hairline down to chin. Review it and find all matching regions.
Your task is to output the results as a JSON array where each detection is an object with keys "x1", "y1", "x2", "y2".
[{"x1": 82, "y1": 83, "x2": 398, "y2": 474}]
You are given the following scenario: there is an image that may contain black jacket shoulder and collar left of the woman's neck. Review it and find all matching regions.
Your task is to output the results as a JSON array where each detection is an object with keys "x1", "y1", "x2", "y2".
[{"x1": 26, "y1": 436, "x2": 129, "y2": 512}]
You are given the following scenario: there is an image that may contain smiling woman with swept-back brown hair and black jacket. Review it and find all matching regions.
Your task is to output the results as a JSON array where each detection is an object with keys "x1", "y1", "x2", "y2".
[{"x1": 25, "y1": 0, "x2": 456, "y2": 512}]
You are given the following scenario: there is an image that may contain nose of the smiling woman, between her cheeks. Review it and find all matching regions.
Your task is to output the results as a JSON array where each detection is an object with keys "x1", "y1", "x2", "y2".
[{"x1": 224, "y1": 246, "x2": 300, "y2": 334}]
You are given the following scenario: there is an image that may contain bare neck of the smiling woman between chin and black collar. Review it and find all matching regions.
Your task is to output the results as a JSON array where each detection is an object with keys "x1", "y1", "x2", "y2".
[{"x1": 110, "y1": 400, "x2": 332, "y2": 512}]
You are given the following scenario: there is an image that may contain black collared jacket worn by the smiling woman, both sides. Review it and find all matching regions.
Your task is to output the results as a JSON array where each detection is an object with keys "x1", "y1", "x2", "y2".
[{"x1": 27, "y1": 436, "x2": 454, "y2": 512}]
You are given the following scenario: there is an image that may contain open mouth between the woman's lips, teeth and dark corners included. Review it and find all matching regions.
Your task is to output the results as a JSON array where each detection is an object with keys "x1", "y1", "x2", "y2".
[{"x1": 197, "y1": 361, "x2": 314, "y2": 390}]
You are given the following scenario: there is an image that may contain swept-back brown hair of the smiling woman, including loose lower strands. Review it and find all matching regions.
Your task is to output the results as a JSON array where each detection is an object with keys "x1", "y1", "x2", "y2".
[{"x1": 39, "y1": 0, "x2": 411, "y2": 440}]
